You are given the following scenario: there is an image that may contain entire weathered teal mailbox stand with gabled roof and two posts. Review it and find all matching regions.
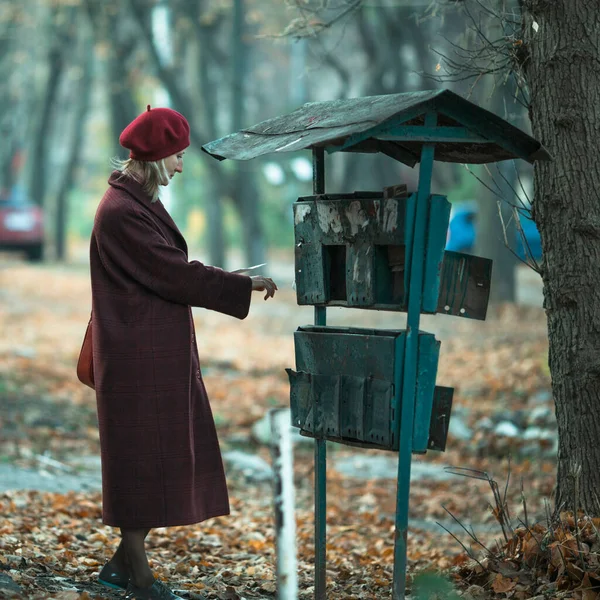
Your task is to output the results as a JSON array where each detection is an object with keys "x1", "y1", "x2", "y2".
[{"x1": 202, "y1": 90, "x2": 550, "y2": 600}]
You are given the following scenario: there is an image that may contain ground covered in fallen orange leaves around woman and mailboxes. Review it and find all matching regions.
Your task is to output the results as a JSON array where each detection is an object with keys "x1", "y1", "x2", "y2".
[{"x1": 0, "y1": 262, "x2": 564, "y2": 600}]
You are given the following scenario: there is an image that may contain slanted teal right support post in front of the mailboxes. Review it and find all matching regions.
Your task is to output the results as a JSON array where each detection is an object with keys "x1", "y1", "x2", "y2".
[{"x1": 392, "y1": 113, "x2": 437, "y2": 600}]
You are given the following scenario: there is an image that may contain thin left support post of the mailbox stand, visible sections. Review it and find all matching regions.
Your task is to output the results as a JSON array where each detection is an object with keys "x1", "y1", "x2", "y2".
[{"x1": 312, "y1": 148, "x2": 327, "y2": 600}]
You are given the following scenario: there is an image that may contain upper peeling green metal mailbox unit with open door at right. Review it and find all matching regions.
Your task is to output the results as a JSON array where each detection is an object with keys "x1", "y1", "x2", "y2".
[{"x1": 294, "y1": 192, "x2": 491, "y2": 319}]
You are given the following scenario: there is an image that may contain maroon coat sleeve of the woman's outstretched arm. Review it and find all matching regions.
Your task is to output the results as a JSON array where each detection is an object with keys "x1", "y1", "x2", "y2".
[{"x1": 95, "y1": 202, "x2": 252, "y2": 319}]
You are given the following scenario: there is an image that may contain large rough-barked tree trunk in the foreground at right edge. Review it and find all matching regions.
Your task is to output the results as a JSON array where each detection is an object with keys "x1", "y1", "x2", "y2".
[{"x1": 521, "y1": 0, "x2": 600, "y2": 515}]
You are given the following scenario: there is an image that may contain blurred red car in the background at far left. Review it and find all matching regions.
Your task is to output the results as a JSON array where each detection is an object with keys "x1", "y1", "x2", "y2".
[{"x1": 0, "y1": 193, "x2": 44, "y2": 261}]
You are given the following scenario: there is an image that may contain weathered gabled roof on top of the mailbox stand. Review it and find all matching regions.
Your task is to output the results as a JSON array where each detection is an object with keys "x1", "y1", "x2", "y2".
[{"x1": 202, "y1": 90, "x2": 551, "y2": 167}]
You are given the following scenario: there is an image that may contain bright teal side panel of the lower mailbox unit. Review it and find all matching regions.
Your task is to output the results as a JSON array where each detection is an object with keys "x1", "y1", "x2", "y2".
[{"x1": 412, "y1": 333, "x2": 440, "y2": 453}]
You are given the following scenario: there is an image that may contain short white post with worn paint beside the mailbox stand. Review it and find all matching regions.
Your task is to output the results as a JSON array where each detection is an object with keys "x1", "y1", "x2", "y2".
[{"x1": 269, "y1": 408, "x2": 298, "y2": 600}]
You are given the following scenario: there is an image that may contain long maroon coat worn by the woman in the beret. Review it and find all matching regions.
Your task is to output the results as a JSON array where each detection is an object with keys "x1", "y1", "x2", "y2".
[{"x1": 90, "y1": 171, "x2": 252, "y2": 528}]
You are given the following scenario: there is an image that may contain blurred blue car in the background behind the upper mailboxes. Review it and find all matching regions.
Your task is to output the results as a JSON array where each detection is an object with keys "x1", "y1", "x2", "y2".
[{"x1": 446, "y1": 202, "x2": 542, "y2": 260}]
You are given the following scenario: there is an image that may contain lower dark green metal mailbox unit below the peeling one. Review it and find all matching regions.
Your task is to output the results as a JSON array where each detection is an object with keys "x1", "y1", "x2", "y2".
[{"x1": 287, "y1": 326, "x2": 452, "y2": 453}]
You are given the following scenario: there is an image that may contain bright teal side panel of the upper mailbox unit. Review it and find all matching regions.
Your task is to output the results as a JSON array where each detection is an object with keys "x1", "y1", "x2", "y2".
[{"x1": 422, "y1": 195, "x2": 451, "y2": 313}]
